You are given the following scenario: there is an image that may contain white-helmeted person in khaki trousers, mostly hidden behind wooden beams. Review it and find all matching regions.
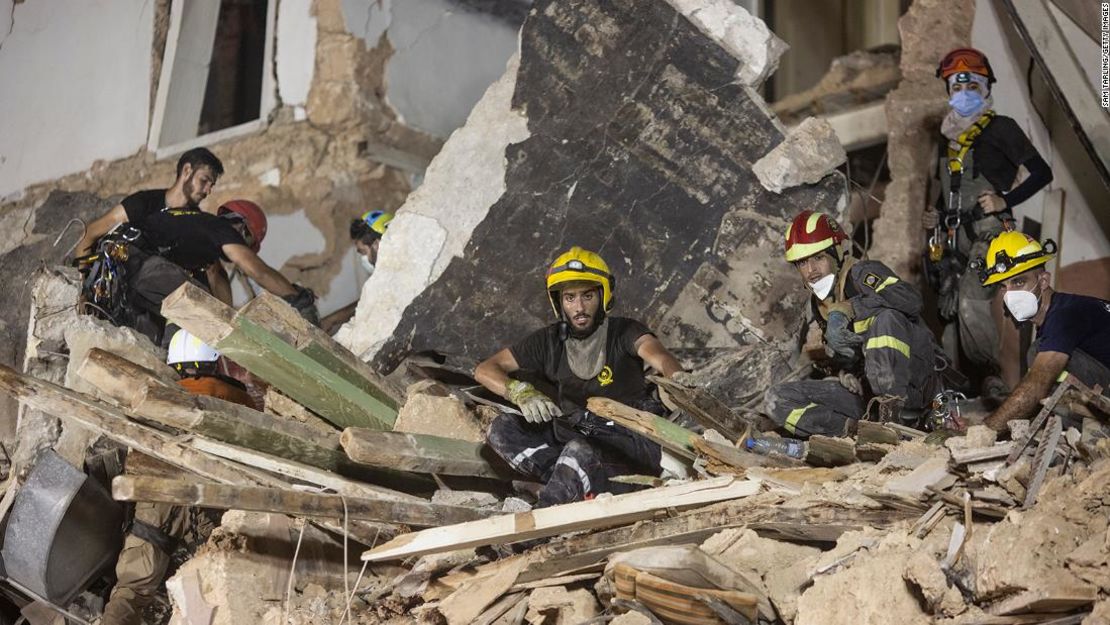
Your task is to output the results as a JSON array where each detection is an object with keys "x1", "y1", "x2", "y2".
[{"x1": 100, "y1": 330, "x2": 251, "y2": 625}]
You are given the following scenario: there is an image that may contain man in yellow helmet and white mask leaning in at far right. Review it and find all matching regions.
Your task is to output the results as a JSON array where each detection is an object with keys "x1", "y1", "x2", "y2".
[{"x1": 980, "y1": 232, "x2": 1110, "y2": 430}]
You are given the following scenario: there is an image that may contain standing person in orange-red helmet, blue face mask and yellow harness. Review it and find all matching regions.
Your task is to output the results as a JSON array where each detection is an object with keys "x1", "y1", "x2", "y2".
[{"x1": 921, "y1": 48, "x2": 1052, "y2": 405}]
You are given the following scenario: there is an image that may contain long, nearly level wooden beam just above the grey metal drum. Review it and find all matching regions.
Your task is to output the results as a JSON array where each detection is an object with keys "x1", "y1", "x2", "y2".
[{"x1": 112, "y1": 475, "x2": 491, "y2": 527}]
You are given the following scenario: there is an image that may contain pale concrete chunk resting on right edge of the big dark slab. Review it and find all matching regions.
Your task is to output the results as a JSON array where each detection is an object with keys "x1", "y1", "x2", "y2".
[{"x1": 751, "y1": 118, "x2": 848, "y2": 193}]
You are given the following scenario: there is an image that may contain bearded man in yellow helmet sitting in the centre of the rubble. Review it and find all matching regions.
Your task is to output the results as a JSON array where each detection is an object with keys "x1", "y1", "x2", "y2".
[{"x1": 474, "y1": 246, "x2": 682, "y2": 506}]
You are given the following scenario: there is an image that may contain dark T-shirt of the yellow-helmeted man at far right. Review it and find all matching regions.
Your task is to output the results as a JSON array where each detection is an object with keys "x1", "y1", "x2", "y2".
[{"x1": 1037, "y1": 293, "x2": 1110, "y2": 369}]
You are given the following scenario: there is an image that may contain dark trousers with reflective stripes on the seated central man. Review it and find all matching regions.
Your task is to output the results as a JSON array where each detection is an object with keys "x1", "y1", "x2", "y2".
[{"x1": 488, "y1": 411, "x2": 662, "y2": 507}]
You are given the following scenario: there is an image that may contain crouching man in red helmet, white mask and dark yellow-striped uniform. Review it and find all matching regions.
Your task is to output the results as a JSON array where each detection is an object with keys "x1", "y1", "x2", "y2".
[{"x1": 765, "y1": 211, "x2": 942, "y2": 438}]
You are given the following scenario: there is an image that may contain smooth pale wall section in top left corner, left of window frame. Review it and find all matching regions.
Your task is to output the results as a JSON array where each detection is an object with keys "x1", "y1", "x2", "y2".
[{"x1": 0, "y1": 0, "x2": 154, "y2": 199}]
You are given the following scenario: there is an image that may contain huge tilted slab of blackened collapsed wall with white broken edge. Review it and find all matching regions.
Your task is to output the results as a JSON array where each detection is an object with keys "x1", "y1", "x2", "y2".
[{"x1": 337, "y1": 0, "x2": 844, "y2": 370}]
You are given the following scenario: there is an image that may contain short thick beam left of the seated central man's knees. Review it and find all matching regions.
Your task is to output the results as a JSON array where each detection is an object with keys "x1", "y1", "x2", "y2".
[{"x1": 340, "y1": 427, "x2": 513, "y2": 480}]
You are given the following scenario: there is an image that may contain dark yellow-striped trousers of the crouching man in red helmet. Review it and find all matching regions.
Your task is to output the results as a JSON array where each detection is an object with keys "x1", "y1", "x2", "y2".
[{"x1": 764, "y1": 310, "x2": 940, "y2": 438}]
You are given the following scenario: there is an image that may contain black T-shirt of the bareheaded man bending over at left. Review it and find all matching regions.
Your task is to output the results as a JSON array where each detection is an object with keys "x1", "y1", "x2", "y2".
[{"x1": 121, "y1": 189, "x2": 246, "y2": 272}]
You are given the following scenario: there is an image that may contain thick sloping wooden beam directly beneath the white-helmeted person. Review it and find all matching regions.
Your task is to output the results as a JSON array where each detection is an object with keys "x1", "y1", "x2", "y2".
[{"x1": 77, "y1": 347, "x2": 432, "y2": 497}]
